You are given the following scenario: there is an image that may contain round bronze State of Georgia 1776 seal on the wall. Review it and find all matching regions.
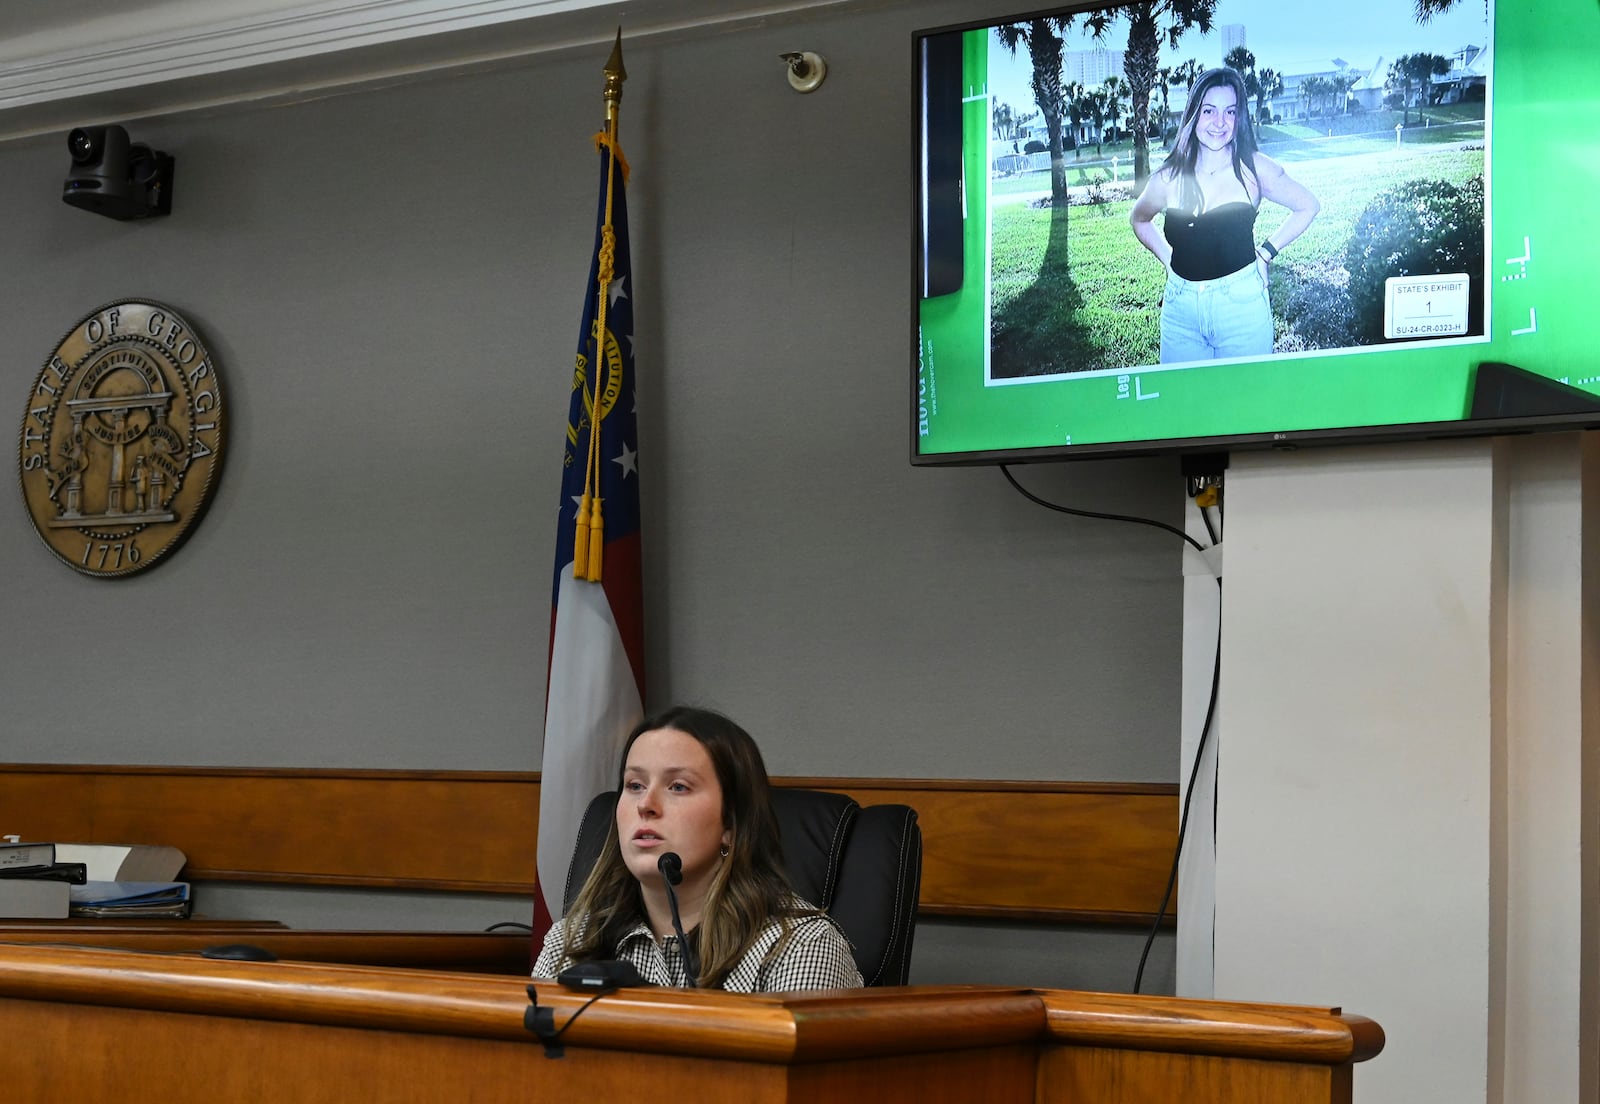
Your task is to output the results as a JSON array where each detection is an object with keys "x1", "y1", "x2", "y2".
[{"x1": 21, "y1": 301, "x2": 222, "y2": 576}]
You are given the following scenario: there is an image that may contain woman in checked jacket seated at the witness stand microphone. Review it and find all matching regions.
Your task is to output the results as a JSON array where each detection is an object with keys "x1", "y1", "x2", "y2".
[{"x1": 533, "y1": 707, "x2": 862, "y2": 992}]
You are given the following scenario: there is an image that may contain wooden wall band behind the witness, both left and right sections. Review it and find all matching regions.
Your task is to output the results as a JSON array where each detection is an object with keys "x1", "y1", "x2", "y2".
[{"x1": 0, "y1": 763, "x2": 1178, "y2": 923}]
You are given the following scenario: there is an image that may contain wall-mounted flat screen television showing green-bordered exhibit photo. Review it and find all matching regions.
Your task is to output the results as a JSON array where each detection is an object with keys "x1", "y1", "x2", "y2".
[{"x1": 910, "y1": 0, "x2": 1600, "y2": 464}]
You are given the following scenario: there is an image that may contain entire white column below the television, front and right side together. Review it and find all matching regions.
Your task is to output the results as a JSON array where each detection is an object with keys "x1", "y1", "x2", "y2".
[{"x1": 1214, "y1": 434, "x2": 1600, "y2": 1104}]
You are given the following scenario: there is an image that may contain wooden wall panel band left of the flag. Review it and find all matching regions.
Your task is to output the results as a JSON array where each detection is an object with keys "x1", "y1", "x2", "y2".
[{"x1": 0, "y1": 766, "x2": 539, "y2": 893}]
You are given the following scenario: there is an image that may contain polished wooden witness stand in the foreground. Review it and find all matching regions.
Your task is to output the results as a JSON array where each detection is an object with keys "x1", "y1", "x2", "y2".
[{"x1": 0, "y1": 925, "x2": 1382, "y2": 1104}]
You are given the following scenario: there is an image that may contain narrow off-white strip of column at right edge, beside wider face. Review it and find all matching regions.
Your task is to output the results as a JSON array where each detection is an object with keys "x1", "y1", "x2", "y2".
[{"x1": 1490, "y1": 434, "x2": 1600, "y2": 1104}]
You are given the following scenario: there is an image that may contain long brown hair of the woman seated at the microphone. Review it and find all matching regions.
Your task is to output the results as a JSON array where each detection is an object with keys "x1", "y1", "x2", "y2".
[{"x1": 566, "y1": 706, "x2": 803, "y2": 987}]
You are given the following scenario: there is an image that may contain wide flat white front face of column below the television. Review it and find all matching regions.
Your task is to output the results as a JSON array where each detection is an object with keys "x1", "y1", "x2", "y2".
[{"x1": 1216, "y1": 442, "x2": 1494, "y2": 1104}]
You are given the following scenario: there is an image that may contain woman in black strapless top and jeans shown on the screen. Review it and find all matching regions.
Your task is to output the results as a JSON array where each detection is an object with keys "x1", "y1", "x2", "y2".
[{"x1": 1130, "y1": 69, "x2": 1320, "y2": 365}]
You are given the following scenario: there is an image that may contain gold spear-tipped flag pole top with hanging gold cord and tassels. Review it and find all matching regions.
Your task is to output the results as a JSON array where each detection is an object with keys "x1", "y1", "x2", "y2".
[{"x1": 573, "y1": 27, "x2": 627, "y2": 582}]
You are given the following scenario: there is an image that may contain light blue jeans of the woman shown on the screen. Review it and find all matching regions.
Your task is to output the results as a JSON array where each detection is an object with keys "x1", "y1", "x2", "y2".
[{"x1": 1162, "y1": 264, "x2": 1272, "y2": 365}]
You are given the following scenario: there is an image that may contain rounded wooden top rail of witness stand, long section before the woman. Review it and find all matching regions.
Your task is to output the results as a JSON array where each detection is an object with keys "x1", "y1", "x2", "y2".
[{"x1": 0, "y1": 942, "x2": 1045, "y2": 1062}]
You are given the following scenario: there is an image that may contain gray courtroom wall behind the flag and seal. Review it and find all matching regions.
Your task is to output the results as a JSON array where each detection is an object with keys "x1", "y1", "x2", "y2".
[{"x1": 0, "y1": 3, "x2": 1181, "y2": 990}]
